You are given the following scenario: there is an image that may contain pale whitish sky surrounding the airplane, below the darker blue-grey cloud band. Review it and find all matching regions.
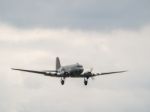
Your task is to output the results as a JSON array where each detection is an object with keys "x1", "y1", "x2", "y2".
[{"x1": 0, "y1": 25, "x2": 150, "y2": 112}]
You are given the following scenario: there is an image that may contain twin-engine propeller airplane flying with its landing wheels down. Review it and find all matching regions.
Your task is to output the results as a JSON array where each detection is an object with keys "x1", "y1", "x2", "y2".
[{"x1": 11, "y1": 57, "x2": 126, "y2": 85}]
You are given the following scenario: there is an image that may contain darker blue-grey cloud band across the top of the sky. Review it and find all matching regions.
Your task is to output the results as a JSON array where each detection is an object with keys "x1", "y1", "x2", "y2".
[{"x1": 0, "y1": 0, "x2": 150, "y2": 30}]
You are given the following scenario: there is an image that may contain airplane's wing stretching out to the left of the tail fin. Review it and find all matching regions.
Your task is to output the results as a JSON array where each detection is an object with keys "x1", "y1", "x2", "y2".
[{"x1": 11, "y1": 68, "x2": 57, "y2": 77}]
